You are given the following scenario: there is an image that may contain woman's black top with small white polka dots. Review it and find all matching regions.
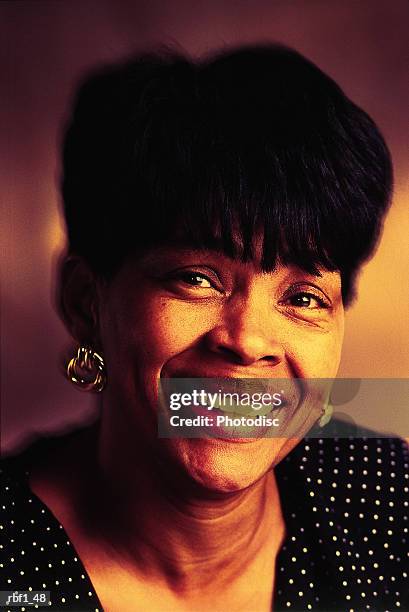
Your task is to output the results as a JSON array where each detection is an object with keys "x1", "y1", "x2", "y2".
[{"x1": 0, "y1": 428, "x2": 409, "y2": 612}]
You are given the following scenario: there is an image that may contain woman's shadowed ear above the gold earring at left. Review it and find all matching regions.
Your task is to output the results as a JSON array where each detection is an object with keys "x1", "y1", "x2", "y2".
[{"x1": 57, "y1": 255, "x2": 100, "y2": 348}]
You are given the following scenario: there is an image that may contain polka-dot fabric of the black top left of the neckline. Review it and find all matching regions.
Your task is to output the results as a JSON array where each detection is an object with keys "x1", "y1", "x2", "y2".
[{"x1": 0, "y1": 467, "x2": 103, "y2": 612}]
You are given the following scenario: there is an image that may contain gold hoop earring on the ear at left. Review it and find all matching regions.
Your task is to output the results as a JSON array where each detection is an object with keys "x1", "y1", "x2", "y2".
[{"x1": 67, "y1": 346, "x2": 107, "y2": 393}]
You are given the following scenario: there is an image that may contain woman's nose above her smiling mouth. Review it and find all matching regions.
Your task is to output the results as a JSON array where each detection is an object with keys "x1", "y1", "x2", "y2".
[{"x1": 206, "y1": 296, "x2": 284, "y2": 366}]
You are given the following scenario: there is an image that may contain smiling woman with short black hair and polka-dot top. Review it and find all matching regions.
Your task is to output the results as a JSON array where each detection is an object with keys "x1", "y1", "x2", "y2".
[{"x1": 4, "y1": 45, "x2": 409, "y2": 612}]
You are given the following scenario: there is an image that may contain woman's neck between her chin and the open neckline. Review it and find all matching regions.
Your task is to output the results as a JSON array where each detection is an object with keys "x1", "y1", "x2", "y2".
[{"x1": 79, "y1": 412, "x2": 284, "y2": 592}]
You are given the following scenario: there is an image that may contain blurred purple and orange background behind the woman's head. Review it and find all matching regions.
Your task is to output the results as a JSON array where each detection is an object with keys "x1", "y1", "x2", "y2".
[{"x1": 0, "y1": 0, "x2": 409, "y2": 446}]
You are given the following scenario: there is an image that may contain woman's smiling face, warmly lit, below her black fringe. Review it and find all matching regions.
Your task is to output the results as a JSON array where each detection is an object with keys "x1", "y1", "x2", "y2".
[{"x1": 99, "y1": 247, "x2": 344, "y2": 491}]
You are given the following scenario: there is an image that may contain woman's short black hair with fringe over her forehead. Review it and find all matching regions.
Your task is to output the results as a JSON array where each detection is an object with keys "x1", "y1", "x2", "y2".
[{"x1": 62, "y1": 44, "x2": 392, "y2": 304}]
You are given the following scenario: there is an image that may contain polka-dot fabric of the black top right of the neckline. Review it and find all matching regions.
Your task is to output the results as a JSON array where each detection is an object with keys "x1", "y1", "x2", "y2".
[{"x1": 273, "y1": 438, "x2": 409, "y2": 612}]
